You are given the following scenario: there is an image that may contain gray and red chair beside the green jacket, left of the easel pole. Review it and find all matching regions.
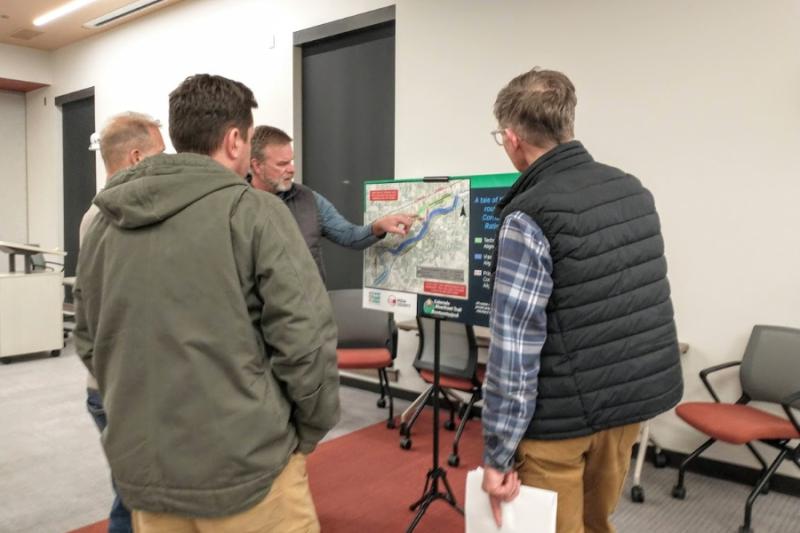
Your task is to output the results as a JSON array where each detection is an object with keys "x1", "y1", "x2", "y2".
[{"x1": 328, "y1": 289, "x2": 397, "y2": 429}]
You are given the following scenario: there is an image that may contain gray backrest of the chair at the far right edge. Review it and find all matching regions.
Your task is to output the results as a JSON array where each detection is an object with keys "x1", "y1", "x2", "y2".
[{"x1": 740, "y1": 326, "x2": 800, "y2": 403}]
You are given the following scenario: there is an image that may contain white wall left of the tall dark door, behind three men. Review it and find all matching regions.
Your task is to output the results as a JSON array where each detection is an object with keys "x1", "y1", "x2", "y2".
[{"x1": 28, "y1": 0, "x2": 390, "y2": 247}]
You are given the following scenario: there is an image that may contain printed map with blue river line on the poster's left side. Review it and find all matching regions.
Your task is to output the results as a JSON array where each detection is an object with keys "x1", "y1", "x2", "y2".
[{"x1": 364, "y1": 179, "x2": 470, "y2": 299}]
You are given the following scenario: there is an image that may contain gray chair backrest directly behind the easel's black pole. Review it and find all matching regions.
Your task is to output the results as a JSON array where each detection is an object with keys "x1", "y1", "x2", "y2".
[{"x1": 414, "y1": 317, "x2": 478, "y2": 379}]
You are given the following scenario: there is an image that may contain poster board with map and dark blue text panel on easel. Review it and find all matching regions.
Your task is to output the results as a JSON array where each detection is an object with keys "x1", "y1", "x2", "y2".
[{"x1": 363, "y1": 173, "x2": 519, "y2": 326}]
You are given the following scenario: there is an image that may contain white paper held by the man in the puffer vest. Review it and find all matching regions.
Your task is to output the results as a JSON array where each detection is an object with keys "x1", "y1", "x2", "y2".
[{"x1": 464, "y1": 467, "x2": 558, "y2": 533}]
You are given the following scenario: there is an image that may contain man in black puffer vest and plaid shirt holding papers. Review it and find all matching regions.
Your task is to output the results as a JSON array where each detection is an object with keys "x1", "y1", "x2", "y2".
[{"x1": 483, "y1": 68, "x2": 683, "y2": 533}]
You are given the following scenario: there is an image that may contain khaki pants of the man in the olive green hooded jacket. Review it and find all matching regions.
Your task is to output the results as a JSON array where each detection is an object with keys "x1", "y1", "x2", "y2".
[{"x1": 132, "y1": 453, "x2": 320, "y2": 533}]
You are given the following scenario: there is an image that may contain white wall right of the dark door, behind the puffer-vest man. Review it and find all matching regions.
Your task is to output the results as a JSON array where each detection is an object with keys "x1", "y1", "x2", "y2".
[{"x1": 396, "y1": 0, "x2": 800, "y2": 476}]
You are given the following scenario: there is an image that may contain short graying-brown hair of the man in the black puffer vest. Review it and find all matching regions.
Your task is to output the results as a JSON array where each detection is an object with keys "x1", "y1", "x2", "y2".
[{"x1": 494, "y1": 67, "x2": 578, "y2": 147}]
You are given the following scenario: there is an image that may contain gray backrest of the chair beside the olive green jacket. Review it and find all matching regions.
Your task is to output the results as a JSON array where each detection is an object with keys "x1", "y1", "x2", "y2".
[{"x1": 328, "y1": 289, "x2": 397, "y2": 358}]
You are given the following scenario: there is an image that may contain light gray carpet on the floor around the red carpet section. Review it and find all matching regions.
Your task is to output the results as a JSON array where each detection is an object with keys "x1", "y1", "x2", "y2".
[{"x1": 0, "y1": 347, "x2": 800, "y2": 533}]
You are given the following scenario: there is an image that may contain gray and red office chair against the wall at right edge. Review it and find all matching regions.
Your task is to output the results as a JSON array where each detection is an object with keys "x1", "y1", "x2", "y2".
[{"x1": 672, "y1": 326, "x2": 800, "y2": 533}]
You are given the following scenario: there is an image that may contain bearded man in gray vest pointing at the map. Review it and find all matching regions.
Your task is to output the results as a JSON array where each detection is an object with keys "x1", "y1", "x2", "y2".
[{"x1": 250, "y1": 126, "x2": 414, "y2": 281}]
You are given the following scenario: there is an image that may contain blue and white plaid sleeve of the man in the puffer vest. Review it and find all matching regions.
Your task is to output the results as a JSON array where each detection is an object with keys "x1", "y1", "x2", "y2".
[{"x1": 482, "y1": 211, "x2": 553, "y2": 472}]
